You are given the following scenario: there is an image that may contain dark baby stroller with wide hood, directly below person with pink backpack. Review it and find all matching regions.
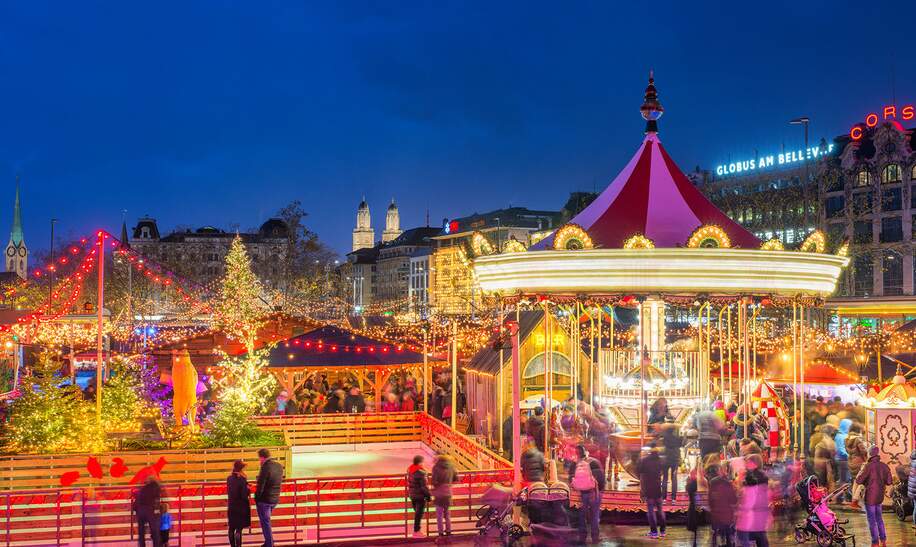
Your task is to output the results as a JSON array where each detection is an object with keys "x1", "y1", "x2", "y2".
[{"x1": 524, "y1": 483, "x2": 576, "y2": 547}]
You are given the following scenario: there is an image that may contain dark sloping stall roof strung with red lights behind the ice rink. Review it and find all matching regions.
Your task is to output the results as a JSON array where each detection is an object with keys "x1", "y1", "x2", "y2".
[{"x1": 270, "y1": 325, "x2": 438, "y2": 368}]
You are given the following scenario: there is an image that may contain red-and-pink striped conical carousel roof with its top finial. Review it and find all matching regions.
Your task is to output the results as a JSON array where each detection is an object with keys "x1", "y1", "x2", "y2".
[{"x1": 530, "y1": 76, "x2": 761, "y2": 251}]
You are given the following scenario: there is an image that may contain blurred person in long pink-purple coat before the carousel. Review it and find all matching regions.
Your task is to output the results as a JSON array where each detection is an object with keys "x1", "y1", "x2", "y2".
[{"x1": 732, "y1": 454, "x2": 771, "y2": 547}]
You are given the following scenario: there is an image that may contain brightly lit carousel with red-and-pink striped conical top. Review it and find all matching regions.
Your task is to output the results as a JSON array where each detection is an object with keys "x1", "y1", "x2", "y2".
[{"x1": 470, "y1": 75, "x2": 848, "y2": 484}]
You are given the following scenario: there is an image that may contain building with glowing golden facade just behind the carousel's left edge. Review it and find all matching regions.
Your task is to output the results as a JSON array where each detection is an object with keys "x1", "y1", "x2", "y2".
[{"x1": 428, "y1": 207, "x2": 563, "y2": 314}]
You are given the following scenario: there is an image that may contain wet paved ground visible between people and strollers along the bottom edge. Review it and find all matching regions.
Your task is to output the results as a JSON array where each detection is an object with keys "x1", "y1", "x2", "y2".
[{"x1": 366, "y1": 512, "x2": 916, "y2": 547}]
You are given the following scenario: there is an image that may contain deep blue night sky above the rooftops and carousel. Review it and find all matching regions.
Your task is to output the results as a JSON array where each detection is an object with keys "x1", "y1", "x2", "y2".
[{"x1": 0, "y1": 0, "x2": 916, "y2": 252}]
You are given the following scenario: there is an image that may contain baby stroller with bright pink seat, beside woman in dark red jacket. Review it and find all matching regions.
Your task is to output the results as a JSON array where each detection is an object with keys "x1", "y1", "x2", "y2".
[{"x1": 795, "y1": 475, "x2": 856, "y2": 547}]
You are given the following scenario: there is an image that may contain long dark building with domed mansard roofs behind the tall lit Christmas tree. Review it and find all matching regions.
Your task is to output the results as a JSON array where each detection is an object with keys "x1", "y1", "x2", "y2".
[{"x1": 129, "y1": 217, "x2": 290, "y2": 288}]
